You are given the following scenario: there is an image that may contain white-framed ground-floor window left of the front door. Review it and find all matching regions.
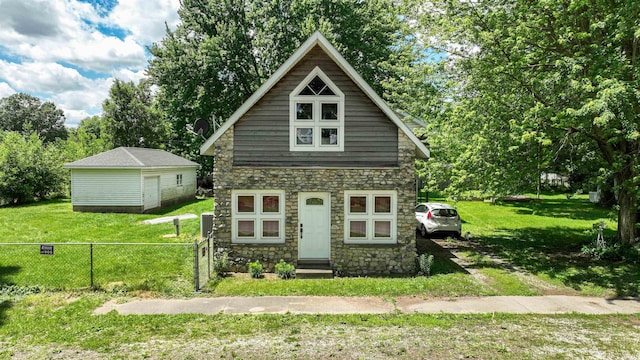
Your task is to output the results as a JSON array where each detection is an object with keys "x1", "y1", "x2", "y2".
[{"x1": 231, "y1": 190, "x2": 285, "y2": 244}]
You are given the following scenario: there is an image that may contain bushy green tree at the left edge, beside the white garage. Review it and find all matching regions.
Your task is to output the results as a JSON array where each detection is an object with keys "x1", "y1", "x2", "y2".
[{"x1": 0, "y1": 131, "x2": 65, "y2": 204}]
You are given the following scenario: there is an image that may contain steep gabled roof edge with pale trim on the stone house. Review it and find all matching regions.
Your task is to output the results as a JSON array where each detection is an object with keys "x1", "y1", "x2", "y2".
[{"x1": 200, "y1": 31, "x2": 429, "y2": 158}]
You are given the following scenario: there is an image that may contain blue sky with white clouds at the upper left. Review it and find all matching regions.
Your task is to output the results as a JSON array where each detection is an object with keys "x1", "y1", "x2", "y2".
[{"x1": 0, "y1": 0, "x2": 179, "y2": 126}]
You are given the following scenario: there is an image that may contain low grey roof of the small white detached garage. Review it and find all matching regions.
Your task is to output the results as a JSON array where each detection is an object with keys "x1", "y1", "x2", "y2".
[{"x1": 64, "y1": 147, "x2": 199, "y2": 169}]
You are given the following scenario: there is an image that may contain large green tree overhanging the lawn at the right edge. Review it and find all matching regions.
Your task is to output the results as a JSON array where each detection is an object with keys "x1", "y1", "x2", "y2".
[{"x1": 422, "y1": 0, "x2": 640, "y2": 243}]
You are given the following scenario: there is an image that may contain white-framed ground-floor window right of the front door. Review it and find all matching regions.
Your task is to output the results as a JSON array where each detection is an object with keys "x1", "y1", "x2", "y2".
[{"x1": 344, "y1": 190, "x2": 397, "y2": 244}]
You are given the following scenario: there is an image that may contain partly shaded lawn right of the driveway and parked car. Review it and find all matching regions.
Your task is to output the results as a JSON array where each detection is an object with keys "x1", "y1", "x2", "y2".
[{"x1": 456, "y1": 195, "x2": 640, "y2": 296}]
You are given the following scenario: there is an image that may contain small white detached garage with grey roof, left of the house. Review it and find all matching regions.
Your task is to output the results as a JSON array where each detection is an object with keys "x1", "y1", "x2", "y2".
[{"x1": 64, "y1": 147, "x2": 198, "y2": 213}]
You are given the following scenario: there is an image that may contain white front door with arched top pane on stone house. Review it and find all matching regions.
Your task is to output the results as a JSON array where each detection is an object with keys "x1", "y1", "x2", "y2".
[{"x1": 298, "y1": 193, "x2": 331, "y2": 260}]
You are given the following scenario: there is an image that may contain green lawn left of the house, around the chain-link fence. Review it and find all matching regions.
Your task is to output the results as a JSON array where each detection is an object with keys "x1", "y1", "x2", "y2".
[{"x1": 0, "y1": 199, "x2": 213, "y2": 295}]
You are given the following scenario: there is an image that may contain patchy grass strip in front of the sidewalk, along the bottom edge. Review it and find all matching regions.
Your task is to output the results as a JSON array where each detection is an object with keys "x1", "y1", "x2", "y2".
[{"x1": 0, "y1": 293, "x2": 640, "y2": 359}]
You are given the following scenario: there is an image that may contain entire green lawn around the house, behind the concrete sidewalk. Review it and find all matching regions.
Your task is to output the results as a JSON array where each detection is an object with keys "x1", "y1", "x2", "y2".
[{"x1": 0, "y1": 195, "x2": 640, "y2": 297}]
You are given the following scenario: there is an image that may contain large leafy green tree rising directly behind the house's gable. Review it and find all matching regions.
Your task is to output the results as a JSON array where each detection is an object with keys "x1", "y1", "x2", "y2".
[{"x1": 148, "y1": 0, "x2": 430, "y2": 171}]
